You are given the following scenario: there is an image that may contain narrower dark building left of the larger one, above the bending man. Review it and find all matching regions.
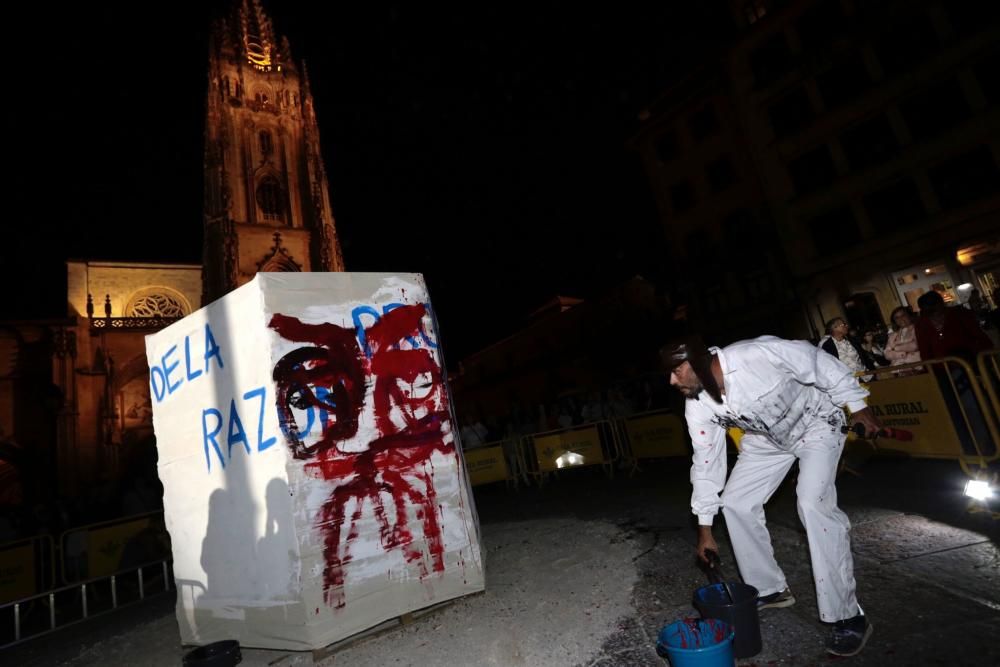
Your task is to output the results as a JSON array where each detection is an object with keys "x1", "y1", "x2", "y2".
[{"x1": 631, "y1": 61, "x2": 803, "y2": 342}]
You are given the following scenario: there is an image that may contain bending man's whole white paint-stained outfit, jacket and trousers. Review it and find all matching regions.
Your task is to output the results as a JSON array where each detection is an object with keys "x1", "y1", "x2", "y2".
[{"x1": 685, "y1": 336, "x2": 868, "y2": 621}]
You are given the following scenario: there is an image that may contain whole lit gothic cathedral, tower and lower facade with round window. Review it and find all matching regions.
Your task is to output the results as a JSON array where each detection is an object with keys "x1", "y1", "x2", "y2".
[{"x1": 0, "y1": 0, "x2": 344, "y2": 502}]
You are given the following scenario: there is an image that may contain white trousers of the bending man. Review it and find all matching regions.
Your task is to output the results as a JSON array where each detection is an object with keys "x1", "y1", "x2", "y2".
[{"x1": 722, "y1": 424, "x2": 861, "y2": 623}]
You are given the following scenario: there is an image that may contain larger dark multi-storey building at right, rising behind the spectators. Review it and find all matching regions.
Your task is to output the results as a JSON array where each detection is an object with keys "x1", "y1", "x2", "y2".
[{"x1": 647, "y1": 0, "x2": 1000, "y2": 335}]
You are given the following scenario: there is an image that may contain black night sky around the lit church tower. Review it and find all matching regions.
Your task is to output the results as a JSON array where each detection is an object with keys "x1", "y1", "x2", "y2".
[{"x1": 7, "y1": 0, "x2": 733, "y2": 359}]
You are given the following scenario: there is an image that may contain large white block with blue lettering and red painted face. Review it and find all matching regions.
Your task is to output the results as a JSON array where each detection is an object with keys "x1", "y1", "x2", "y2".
[{"x1": 146, "y1": 273, "x2": 484, "y2": 650}]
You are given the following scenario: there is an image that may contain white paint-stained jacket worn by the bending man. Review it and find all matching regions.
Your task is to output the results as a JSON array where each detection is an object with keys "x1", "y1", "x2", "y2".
[{"x1": 684, "y1": 336, "x2": 868, "y2": 526}]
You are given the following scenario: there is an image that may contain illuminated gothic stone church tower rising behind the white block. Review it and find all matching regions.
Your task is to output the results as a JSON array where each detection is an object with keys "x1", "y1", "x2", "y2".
[{"x1": 202, "y1": 0, "x2": 344, "y2": 304}]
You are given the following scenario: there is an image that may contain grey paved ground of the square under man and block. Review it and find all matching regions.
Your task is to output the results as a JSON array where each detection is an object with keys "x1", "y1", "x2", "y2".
[{"x1": 0, "y1": 452, "x2": 1000, "y2": 667}]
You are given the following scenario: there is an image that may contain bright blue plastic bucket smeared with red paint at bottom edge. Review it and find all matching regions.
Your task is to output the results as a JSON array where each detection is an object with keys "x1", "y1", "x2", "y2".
[{"x1": 656, "y1": 618, "x2": 735, "y2": 667}]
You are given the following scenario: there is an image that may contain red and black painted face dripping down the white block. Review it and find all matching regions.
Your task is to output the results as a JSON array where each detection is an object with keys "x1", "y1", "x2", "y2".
[{"x1": 270, "y1": 305, "x2": 455, "y2": 607}]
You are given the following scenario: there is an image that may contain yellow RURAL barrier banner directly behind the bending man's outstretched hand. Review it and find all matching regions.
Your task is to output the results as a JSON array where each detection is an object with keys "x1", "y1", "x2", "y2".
[{"x1": 867, "y1": 373, "x2": 962, "y2": 459}]
